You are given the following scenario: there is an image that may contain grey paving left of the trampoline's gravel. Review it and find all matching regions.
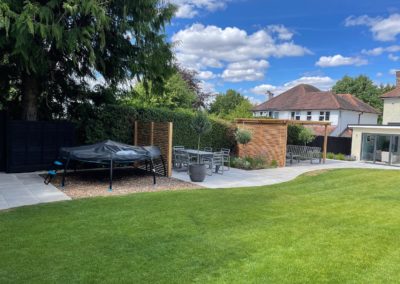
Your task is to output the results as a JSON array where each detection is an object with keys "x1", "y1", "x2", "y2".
[{"x1": 0, "y1": 173, "x2": 71, "y2": 210}]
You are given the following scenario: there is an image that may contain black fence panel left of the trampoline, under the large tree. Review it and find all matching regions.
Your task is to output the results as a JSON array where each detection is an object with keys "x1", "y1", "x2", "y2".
[{"x1": 6, "y1": 121, "x2": 75, "y2": 173}]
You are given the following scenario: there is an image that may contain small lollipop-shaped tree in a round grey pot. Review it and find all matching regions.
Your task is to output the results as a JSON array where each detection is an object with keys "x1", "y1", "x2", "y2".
[{"x1": 189, "y1": 111, "x2": 211, "y2": 182}]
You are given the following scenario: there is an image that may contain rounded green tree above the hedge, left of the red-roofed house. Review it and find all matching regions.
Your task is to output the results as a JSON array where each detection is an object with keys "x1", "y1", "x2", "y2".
[{"x1": 210, "y1": 90, "x2": 252, "y2": 119}]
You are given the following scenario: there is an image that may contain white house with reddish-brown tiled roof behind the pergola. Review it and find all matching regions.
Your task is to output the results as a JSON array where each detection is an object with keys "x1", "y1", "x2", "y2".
[{"x1": 253, "y1": 84, "x2": 379, "y2": 136}]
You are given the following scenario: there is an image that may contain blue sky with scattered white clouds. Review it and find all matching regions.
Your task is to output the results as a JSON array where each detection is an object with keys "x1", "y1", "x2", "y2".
[{"x1": 167, "y1": 0, "x2": 400, "y2": 103}]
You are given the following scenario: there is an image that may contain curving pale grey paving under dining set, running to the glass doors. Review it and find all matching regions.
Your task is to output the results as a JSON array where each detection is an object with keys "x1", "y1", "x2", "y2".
[{"x1": 172, "y1": 160, "x2": 400, "y2": 188}]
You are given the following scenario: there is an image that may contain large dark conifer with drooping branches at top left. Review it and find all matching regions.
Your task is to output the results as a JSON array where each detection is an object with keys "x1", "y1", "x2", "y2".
[{"x1": 0, "y1": 0, "x2": 175, "y2": 120}]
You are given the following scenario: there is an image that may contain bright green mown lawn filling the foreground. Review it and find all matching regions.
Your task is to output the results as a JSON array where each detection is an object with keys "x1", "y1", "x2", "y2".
[{"x1": 0, "y1": 170, "x2": 400, "y2": 283}]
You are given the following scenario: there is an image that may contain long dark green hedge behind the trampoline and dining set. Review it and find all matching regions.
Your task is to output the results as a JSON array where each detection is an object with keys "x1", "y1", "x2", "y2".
[{"x1": 76, "y1": 105, "x2": 235, "y2": 149}]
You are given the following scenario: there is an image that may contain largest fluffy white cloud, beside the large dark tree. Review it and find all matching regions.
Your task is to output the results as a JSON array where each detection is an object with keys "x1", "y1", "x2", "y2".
[{"x1": 172, "y1": 24, "x2": 311, "y2": 82}]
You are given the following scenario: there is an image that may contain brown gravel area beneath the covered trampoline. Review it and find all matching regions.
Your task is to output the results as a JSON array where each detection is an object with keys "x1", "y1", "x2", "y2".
[{"x1": 48, "y1": 169, "x2": 201, "y2": 199}]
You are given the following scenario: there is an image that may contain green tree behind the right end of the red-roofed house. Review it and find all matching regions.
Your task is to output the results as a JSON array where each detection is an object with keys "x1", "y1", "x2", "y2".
[{"x1": 332, "y1": 75, "x2": 394, "y2": 111}]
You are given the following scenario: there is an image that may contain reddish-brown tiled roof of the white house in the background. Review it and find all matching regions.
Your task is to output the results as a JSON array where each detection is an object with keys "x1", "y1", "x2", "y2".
[{"x1": 253, "y1": 84, "x2": 378, "y2": 113}]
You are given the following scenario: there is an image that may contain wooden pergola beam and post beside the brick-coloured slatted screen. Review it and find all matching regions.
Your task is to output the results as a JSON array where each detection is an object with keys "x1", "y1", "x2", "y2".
[{"x1": 236, "y1": 118, "x2": 331, "y2": 163}]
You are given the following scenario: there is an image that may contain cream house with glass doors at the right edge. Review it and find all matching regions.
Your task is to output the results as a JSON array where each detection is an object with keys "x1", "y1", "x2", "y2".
[{"x1": 349, "y1": 71, "x2": 400, "y2": 166}]
